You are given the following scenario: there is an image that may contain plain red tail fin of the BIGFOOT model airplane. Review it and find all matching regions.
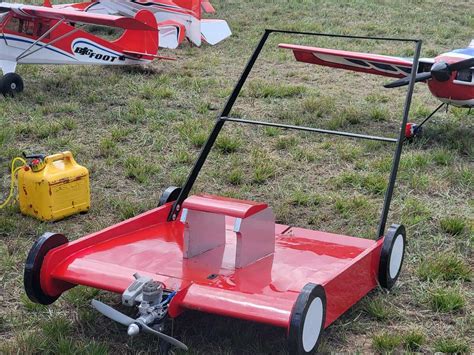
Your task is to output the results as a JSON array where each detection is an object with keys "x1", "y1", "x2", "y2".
[{"x1": 114, "y1": 10, "x2": 159, "y2": 56}]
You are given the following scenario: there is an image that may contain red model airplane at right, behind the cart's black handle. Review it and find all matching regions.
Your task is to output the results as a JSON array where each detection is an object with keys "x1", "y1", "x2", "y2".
[{"x1": 280, "y1": 40, "x2": 474, "y2": 137}]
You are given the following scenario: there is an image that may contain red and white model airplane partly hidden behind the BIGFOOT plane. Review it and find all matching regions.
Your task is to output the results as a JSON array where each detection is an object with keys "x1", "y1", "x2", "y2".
[{"x1": 55, "y1": 0, "x2": 232, "y2": 49}]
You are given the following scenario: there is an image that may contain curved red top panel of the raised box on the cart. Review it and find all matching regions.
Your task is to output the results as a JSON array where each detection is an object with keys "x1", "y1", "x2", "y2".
[{"x1": 183, "y1": 195, "x2": 268, "y2": 218}]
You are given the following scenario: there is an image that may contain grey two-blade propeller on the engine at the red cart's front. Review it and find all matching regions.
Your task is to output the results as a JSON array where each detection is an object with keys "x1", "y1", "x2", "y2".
[{"x1": 92, "y1": 300, "x2": 188, "y2": 350}]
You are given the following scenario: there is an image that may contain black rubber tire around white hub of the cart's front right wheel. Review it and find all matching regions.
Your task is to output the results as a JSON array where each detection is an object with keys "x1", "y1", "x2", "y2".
[{"x1": 288, "y1": 283, "x2": 326, "y2": 355}]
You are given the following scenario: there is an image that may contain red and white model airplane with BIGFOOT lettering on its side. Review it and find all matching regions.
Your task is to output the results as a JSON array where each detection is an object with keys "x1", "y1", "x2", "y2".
[{"x1": 0, "y1": 2, "x2": 167, "y2": 96}]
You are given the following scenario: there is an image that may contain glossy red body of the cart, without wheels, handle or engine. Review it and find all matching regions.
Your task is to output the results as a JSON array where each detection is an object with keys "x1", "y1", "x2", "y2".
[{"x1": 41, "y1": 196, "x2": 383, "y2": 328}]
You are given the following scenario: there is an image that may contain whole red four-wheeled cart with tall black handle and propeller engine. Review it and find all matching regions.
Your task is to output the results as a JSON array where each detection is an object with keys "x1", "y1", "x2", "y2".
[{"x1": 24, "y1": 30, "x2": 421, "y2": 354}]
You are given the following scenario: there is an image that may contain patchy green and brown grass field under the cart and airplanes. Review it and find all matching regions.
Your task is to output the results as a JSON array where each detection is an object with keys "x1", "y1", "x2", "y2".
[{"x1": 0, "y1": 0, "x2": 474, "y2": 354}]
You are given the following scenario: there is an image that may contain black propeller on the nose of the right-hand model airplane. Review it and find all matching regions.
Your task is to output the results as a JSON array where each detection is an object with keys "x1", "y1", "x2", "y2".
[{"x1": 384, "y1": 58, "x2": 474, "y2": 89}]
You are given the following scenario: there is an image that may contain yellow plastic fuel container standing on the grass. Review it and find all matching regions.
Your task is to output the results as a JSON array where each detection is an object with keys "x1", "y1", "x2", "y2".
[{"x1": 18, "y1": 152, "x2": 90, "y2": 221}]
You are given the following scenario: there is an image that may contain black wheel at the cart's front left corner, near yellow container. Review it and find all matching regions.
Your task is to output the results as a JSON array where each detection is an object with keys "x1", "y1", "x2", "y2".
[{"x1": 23, "y1": 233, "x2": 68, "y2": 305}]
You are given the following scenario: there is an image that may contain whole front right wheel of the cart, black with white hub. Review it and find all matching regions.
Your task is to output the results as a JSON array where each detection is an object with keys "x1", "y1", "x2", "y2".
[{"x1": 288, "y1": 283, "x2": 326, "y2": 355}]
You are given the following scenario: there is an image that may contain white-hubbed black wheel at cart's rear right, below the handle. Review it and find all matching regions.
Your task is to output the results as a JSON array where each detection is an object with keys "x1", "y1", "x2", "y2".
[{"x1": 379, "y1": 224, "x2": 406, "y2": 290}]
